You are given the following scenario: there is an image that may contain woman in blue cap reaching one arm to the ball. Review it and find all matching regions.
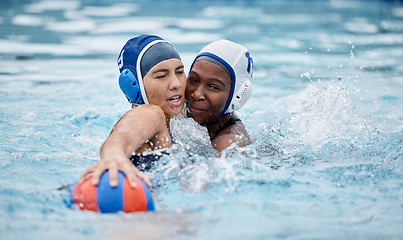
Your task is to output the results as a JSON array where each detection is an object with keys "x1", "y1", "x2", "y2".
[{"x1": 80, "y1": 35, "x2": 186, "y2": 187}]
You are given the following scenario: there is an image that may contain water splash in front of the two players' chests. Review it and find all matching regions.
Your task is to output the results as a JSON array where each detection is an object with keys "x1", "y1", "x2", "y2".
[{"x1": 151, "y1": 117, "x2": 245, "y2": 195}]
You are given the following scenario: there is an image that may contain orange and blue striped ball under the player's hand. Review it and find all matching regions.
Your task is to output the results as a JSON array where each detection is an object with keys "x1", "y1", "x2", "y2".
[{"x1": 69, "y1": 171, "x2": 155, "y2": 213}]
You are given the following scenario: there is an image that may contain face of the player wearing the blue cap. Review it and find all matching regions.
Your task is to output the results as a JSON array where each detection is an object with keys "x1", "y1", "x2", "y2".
[{"x1": 143, "y1": 58, "x2": 186, "y2": 118}]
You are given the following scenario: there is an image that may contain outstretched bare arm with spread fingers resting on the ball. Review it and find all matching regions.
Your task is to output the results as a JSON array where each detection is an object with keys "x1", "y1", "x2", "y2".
[{"x1": 80, "y1": 105, "x2": 171, "y2": 187}]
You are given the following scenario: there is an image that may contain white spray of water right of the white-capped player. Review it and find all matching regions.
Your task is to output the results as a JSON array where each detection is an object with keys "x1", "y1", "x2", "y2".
[{"x1": 249, "y1": 79, "x2": 402, "y2": 165}]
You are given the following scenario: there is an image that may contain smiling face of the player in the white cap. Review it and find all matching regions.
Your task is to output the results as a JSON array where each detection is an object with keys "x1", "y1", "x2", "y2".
[{"x1": 186, "y1": 60, "x2": 231, "y2": 124}]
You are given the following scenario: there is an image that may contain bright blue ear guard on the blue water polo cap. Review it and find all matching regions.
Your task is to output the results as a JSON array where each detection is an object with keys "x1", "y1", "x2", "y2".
[{"x1": 119, "y1": 69, "x2": 144, "y2": 104}]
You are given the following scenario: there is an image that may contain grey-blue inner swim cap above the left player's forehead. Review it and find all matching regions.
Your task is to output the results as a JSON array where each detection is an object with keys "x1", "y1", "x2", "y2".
[{"x1": 140, "y1": 42, "x2": 181, "y2": 78}]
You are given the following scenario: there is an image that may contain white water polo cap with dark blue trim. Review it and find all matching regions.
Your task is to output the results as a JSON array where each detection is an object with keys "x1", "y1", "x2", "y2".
[{"x1": 192, "y1": 39, "x2": 253, "y2": 117}]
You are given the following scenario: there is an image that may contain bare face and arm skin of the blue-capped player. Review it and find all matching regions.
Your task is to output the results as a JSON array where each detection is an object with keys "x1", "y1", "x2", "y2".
[{"x1": 80, "y1": 59, "x2": 186, "y2": 187}]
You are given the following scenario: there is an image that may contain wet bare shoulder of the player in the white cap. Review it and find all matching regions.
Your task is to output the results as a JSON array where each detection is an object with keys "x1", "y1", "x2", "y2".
[{"x1": 211, "y1": 123, "x2": 252, "y2": 151}]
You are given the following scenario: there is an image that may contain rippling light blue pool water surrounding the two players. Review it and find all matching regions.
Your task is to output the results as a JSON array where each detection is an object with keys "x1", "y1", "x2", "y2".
[{"x1": 0, "y1": 0, "x2": 403, "y2": 240}]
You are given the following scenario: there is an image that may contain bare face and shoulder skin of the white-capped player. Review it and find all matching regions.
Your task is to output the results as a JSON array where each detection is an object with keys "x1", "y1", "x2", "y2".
[{"x1": 186, "y1": 60, "x2": 251, "y2": 152}]
